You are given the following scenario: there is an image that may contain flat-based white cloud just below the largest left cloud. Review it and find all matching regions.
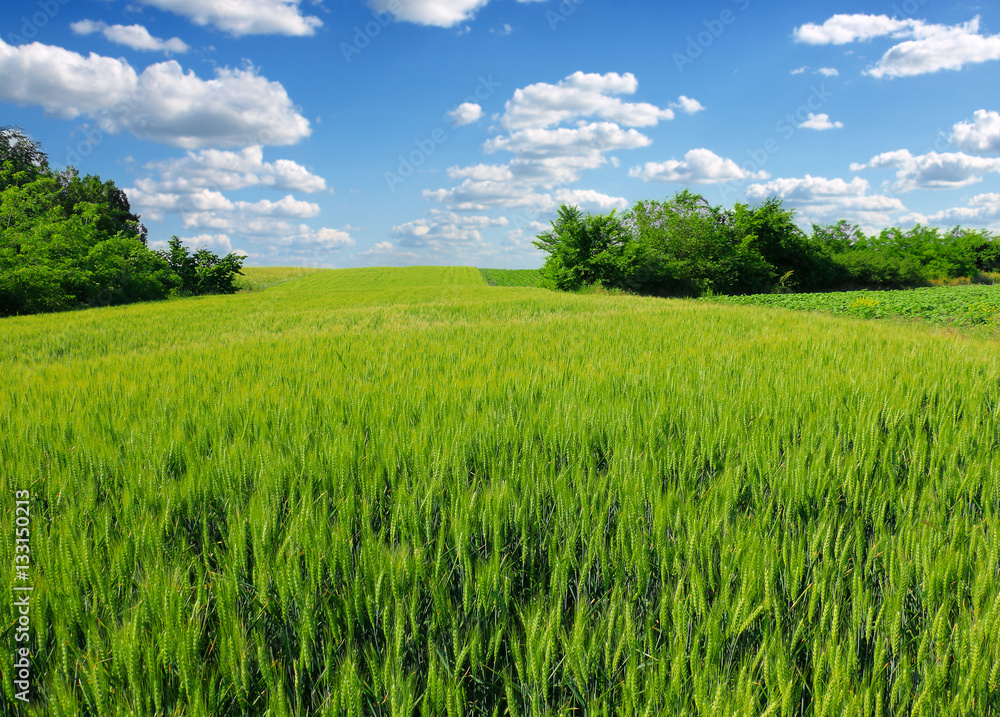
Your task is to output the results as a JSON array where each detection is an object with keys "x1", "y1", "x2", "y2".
[{"x1": 136, "y1": 147, "x2": 326, "y2": 193}]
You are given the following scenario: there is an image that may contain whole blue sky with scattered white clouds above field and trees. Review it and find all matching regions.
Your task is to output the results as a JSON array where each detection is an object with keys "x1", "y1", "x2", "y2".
[{"x1": 0, "y1": 0, "x2": 1000, "y2": 268}]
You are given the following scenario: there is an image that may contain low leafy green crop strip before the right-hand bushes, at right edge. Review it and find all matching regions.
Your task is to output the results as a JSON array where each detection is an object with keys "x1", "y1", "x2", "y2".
[{"x1": 711, "y1": 285, "x2": 1000, "y2": 328}]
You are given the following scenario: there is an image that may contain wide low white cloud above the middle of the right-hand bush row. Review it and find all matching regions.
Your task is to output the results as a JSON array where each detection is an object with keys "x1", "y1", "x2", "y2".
[{"x1": 747, "y1": 174, "x2": 906, "y2": 227}]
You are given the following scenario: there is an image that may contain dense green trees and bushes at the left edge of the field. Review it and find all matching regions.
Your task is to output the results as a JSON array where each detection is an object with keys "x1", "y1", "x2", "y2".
[{"x1": 0, "y1": 127, "x2": 243, "y2": 316}]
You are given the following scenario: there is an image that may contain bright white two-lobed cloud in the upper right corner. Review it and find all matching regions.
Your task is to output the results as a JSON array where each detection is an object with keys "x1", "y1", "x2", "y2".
[{"x1": 794, "y1": 14, "x2": 1000, "y2": 77}]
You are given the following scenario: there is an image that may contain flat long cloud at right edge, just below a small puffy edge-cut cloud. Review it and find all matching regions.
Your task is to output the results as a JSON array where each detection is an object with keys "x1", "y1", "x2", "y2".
[{"x1": 851, "y1": 149, "x2": 1000, "y2": 192}]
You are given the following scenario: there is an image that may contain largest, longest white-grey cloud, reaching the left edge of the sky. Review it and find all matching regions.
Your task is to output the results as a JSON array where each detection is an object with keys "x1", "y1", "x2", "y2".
[{"x1": 0, "y1": 40, "x2": 311, "y2": 149}]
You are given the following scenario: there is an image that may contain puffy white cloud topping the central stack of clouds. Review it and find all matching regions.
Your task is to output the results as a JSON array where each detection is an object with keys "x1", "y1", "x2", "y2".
[{"x1": 502, "y1": 72, "x2": 680, "y2": 130}]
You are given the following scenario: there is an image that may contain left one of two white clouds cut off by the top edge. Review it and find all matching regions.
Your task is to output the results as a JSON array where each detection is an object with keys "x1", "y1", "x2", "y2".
[{"x1": 129, "y1": 0, "x2": 316, "y2": 37}]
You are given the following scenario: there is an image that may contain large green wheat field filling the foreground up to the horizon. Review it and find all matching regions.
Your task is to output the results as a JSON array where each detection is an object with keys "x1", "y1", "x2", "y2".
[{"x1": 0, "y1": 267, "x2": 1000, "y2": 717}]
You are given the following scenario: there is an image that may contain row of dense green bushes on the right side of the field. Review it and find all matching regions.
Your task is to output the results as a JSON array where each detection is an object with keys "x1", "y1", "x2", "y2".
[{"x1": 535, "y1": 190, "x2": 1000, "y2": 296}]
